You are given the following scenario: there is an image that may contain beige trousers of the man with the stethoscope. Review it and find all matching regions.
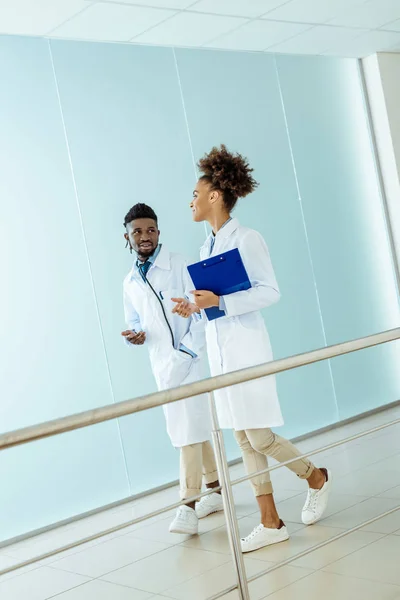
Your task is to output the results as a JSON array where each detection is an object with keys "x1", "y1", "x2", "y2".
[{"x1": 180, "y1": 442, "x2": 218, "y2": 500}]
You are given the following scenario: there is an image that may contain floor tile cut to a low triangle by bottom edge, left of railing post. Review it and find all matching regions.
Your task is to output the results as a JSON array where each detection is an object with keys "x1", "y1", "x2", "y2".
[{"x1": 46, "y1": 579, "x2": 153, "y2": 600}]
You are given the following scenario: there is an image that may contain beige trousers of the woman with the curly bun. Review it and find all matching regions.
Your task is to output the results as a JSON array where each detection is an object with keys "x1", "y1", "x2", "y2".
[{"x1": 234, "y1": 428, "x2": 315, "y2": 496}]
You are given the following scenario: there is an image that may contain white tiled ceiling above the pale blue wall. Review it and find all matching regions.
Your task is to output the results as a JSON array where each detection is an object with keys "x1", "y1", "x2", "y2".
[{"x1": 0, "y1": 0, "x2": 400, "y2": 57}]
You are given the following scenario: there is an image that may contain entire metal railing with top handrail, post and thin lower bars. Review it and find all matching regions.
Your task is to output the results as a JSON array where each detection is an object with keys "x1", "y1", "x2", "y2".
[{"x1": 0, "y1": 328, "x2": 400, "y2": 600}]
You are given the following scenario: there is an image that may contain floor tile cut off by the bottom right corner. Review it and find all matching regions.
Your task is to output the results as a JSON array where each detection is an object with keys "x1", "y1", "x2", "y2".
[{"x1": 265, "y1": 571, "x2": 400, "y2": 600}]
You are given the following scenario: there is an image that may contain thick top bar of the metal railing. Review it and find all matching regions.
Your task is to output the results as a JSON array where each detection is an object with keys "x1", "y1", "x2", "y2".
[{"x1": 0, "y1": 327, "x2": 400, "y2": 450}]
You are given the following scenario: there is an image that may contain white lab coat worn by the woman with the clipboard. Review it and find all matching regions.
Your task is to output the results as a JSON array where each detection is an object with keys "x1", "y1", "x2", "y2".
[{"x1": 200, "y1": 219, "x2": 283, "y2": 431}]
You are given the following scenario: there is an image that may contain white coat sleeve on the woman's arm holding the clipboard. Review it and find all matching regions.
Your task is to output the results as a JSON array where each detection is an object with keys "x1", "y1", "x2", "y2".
[{"x1": 222, "y1": 231, "x2": 280, "y2": 317}]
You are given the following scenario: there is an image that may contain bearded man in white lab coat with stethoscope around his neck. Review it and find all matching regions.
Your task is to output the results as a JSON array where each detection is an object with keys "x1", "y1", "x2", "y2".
[{"x1": 122, "y1": 204, "x2": 223, "y2": 535}]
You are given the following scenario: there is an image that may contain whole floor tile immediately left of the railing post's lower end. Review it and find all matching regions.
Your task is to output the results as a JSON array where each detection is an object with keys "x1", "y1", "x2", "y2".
[{"x1": 102, "y1": 546, "x2": 231, "y2": 594}]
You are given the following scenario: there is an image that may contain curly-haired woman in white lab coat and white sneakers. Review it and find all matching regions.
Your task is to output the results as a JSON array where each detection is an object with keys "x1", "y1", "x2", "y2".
[{"x1": 174, "y1": 145, "x2": 331, "y2": 552}]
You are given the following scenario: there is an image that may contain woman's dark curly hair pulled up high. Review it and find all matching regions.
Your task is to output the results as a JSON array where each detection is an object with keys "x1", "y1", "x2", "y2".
[{"x1": 197, "y1": 144, "x2": 258, "y2": 211}]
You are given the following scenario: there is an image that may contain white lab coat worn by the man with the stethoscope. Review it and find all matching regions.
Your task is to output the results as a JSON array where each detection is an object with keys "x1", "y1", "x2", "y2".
[{"x1": 123, "y1": 246, "x2": 211, "y2": 448}]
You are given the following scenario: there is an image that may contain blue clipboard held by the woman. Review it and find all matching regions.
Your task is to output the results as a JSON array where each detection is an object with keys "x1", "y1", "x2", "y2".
[{"x1": 188, "y1": 248, "x2": 251, "y2": 321}]
